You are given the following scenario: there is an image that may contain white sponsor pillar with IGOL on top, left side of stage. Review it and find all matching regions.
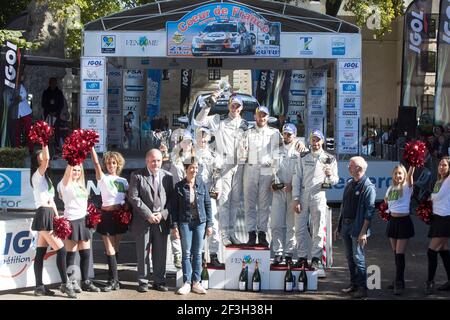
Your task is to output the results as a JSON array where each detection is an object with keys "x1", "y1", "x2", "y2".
[{"x1": 80, "y1": 57, "x2": 107, "y2": 152}]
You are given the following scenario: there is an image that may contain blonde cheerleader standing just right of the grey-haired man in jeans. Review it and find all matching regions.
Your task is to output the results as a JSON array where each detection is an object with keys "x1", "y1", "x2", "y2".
[{"x1": 384, "y1": 164, "x2": 414, "y2": 295}]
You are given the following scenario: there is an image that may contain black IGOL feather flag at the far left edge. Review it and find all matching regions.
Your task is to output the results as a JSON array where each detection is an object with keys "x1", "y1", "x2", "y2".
[{"x1": 0, "y1": 41, "x2": 21, "y2": 147}]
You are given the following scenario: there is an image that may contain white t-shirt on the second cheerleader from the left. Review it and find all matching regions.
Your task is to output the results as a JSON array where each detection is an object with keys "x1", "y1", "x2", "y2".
[{"x1": 56, "y1": 181, "x2": 88, "y2": 221}]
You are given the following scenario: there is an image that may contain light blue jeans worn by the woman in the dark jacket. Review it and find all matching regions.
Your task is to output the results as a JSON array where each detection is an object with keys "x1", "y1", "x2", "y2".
[{"x1": 178, "y1": 221, "x2": 206, "y2": 283}]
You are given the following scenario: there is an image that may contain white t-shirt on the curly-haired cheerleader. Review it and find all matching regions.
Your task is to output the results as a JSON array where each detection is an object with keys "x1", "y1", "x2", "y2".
[{"x1": 98, "y1": 174, "x2": 128, "y2": 206}]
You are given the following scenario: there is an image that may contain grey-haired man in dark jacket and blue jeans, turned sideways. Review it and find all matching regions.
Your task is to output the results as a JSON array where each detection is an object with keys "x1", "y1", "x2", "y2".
[{"x1": 336, "y1": 157, "x2": 376, "y2": 299}]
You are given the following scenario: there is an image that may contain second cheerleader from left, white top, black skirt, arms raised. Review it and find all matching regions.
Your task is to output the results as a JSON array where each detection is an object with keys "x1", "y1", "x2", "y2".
[{"x1": 57, "y1": 165, "x2": 100, "y2": 293}]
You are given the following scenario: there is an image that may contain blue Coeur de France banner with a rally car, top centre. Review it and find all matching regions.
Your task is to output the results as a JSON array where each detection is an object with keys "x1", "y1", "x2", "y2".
[{"x1": 166, "y1": 2, "x2": 281, "y2": 57}]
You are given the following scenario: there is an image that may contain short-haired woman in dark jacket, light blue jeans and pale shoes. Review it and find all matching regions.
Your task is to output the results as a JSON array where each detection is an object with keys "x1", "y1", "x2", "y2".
[{"x1": 172, "y1": 158, "x2": 213, "y2": 295}]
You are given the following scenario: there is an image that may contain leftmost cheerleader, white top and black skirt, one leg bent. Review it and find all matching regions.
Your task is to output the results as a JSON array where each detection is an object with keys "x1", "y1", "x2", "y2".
[{"x1": 30, "y1": 145, "x2": 76, "y2": 298}]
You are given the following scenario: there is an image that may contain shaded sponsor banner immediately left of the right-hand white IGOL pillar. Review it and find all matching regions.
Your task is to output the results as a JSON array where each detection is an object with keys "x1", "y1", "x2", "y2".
[{"x1": 305, "y1": 69, "x2": 327, "y2": 136}]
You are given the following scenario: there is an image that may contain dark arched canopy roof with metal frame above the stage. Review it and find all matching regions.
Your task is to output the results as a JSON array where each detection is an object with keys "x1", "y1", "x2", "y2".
[{"x1": 84, "y1": 0, "x2": 360, "y2": 33}]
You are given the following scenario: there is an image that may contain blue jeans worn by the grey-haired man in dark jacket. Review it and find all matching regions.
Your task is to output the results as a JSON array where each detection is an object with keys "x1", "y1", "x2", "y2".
[{"x1": 341, "y1": 223, "x2": 367, "y2": 289}]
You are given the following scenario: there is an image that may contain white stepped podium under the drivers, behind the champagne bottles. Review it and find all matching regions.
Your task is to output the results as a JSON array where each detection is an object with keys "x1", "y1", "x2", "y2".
[{"x1": 176, "y1": 246, "x2": 319, "y2": 291}]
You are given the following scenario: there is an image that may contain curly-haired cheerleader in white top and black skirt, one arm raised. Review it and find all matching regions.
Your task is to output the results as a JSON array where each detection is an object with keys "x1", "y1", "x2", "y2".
[{"x1": 91, "y1": 148, "x2": 128, "y2": 292}]
